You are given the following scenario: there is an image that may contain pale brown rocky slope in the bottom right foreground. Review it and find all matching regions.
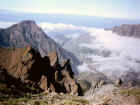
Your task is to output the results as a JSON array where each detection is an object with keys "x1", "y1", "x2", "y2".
[{"x1": 87, "y1": 84, "x2": 140, "y2": 105}]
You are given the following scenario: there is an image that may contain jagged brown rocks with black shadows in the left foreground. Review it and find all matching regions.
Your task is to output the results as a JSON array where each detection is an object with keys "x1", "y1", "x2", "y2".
[{"x1": 0, "y1": 47, "x2": 79, "y2": 95}]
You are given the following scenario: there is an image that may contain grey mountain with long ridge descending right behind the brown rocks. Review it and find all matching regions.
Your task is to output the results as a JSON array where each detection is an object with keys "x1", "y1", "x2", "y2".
[{"x1": 0, "y1": 20, "x2": 80, "y2": 73}]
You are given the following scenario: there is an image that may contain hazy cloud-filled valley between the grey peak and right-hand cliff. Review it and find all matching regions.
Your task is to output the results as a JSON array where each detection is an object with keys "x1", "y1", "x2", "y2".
[{"x1": 40, "y1": 24, "x2": 140, "y2": 85}]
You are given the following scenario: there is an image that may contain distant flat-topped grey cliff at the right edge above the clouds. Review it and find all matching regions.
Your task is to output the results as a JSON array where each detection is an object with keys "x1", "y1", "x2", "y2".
[{"x1": 112, "y1": 24, "x2": 140, "y2": 38}]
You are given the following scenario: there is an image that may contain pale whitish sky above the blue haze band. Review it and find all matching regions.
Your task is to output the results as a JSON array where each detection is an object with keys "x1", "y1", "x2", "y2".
[{"x1": 0, "y1": 0, "x2": 140, "y2": 19}]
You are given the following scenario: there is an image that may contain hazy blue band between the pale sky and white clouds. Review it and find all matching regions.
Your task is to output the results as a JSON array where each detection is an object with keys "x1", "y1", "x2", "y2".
[{"x1": 0, "y1": 9, "x2": 140, "y2": 28}]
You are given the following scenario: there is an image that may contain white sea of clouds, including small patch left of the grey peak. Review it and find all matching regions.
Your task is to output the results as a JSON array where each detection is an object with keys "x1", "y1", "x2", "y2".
[{"x1": 0, "y1": 22, "x2": 140, "y2": 79}]
